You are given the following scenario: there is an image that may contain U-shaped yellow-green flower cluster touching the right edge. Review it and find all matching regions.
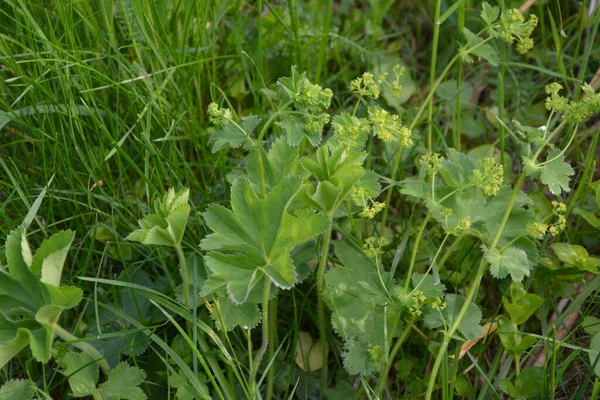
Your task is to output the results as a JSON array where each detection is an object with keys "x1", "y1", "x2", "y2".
[{"x1": 546, "y1": 82, "x2": 600, "y2": 123}]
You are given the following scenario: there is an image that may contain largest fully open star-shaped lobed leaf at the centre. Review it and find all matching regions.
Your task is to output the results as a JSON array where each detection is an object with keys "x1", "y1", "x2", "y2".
[{"x1": 200, "y1": 176, "x2": 329, "y2": 304}]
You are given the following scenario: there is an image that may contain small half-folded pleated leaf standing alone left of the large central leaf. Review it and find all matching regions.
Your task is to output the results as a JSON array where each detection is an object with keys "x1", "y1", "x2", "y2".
[{"x1": 127, "y1": 188, "x2": 190, "y2": 246}]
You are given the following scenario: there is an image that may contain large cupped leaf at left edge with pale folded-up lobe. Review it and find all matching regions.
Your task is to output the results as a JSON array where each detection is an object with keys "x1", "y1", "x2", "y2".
[{"x1": 0, "y1": 226, "x2": 82, "y2": 368}]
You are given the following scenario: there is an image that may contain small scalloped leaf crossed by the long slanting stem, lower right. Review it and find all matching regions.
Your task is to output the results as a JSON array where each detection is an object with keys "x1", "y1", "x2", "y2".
[{"x1": 424, "y1": 294, "x2": 483, "y2": 340}]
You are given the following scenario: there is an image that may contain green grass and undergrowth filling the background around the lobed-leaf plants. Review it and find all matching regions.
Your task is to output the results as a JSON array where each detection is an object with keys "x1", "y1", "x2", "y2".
[{"x1": 0, "y1": 0, "x2": 600, "y2": 399}]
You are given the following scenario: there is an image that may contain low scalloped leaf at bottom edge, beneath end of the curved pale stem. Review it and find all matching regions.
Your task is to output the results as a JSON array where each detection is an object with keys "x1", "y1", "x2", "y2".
[{"x1": 61, "y1": 352, "x2": 147, "y2": 400}]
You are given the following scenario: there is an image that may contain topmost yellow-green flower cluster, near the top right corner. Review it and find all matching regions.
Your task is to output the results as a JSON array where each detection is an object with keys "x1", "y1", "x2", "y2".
[{"x1": 492, "y1": 8, "x2": 538, "y2": 54}]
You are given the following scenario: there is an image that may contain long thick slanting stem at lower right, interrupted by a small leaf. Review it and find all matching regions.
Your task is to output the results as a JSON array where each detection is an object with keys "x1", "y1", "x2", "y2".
[{"x1": 425, "y1": 173, "x2": 526, "y2": 400}]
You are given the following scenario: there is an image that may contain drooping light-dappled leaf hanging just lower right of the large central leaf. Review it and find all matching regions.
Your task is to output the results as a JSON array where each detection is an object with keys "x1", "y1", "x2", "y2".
[{"x1": 323, "y1": 241, "x2": 400, "y2": 375}]
